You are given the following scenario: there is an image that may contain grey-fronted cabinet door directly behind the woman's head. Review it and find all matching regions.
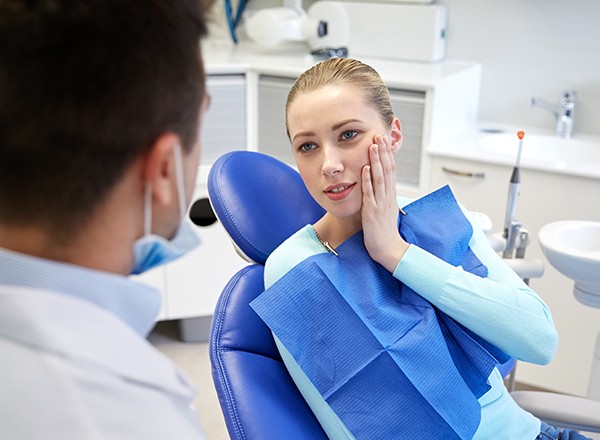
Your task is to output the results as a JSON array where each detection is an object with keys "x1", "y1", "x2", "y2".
[{"x1": 258, "y1": 76, "x2": 425, "y2": 189}]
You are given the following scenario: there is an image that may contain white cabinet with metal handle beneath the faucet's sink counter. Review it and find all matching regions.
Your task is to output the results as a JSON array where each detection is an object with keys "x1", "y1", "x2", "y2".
[{"x1": 430, "y1": 156, "x2": 600, "y2": 396}]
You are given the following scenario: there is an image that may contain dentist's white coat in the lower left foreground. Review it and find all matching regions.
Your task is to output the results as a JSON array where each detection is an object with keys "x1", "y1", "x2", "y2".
[{"x1": 0, "y1": 285, "x2": 204, "y2": 440}]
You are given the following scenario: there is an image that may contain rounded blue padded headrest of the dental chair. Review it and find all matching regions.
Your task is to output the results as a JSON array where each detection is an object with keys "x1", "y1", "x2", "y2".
[{"x1": 208, "y1": 151, "x2": 325, "y2": 264}]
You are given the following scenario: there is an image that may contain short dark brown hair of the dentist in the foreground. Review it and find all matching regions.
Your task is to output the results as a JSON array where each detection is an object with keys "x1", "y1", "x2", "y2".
[{"x1": 0, "y1": 0, "x2": 207, "y2": 237}]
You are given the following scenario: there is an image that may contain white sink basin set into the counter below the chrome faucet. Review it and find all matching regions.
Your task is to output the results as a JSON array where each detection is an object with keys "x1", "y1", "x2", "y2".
[{"x1": 479, "y1": 133, "x2": 600, "y2": 169}]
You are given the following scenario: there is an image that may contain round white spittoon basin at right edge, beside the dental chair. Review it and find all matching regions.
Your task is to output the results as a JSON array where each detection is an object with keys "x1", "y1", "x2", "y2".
[{"x1": 538, "y1": 220, "x2": 600, "y2": 307}]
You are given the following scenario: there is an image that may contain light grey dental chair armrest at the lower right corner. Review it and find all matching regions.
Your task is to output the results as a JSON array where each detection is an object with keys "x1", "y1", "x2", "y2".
[{"x1": 511, "y1": 391, "x2": 600, "y2": 432}]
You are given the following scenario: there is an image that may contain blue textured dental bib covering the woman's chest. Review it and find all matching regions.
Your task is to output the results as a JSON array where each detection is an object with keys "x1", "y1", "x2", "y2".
[{"x1": 251, "y1": 187, "x2": 508, "y2": 439}]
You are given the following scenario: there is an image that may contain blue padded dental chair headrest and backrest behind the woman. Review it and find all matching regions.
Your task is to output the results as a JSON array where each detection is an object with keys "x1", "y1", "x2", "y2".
[{"x1": 208, "y1": 151, "x2": 327, "y2": 440}]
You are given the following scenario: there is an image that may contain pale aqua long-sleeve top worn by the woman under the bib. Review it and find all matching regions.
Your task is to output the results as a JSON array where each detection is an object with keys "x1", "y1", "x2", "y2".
[{"x1": 265, "y1": 197, "x2": 558, "y2": 440}]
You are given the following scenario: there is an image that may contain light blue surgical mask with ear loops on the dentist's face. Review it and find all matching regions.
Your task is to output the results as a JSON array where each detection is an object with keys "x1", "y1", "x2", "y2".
[{"x1": 131, "y1": 145, "x2": 200, "y2": 275}]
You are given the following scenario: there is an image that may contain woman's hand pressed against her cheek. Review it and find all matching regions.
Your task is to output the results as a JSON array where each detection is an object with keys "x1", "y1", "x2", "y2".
[{"x1": 361, "y1": 135, "x2": 408, "y2": 272}]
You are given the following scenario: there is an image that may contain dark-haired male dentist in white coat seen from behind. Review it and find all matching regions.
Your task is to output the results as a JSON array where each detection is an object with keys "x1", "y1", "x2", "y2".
[{"x1": 0, "y1": 0, "x2": 214, "y2": 440}]
